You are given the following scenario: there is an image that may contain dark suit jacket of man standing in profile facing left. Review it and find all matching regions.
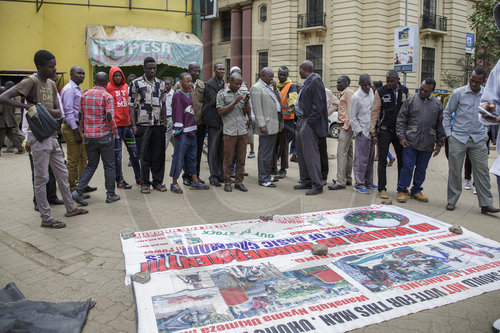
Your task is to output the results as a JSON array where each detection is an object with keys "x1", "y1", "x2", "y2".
[{"x1": 299, "y1": 73, "x2": 328, "y2": 138}]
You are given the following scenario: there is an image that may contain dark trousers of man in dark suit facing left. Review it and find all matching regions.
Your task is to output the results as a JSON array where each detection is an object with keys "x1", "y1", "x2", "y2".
[{"x1": 295, "y1": 118, "x2": 323, "y2": 188}]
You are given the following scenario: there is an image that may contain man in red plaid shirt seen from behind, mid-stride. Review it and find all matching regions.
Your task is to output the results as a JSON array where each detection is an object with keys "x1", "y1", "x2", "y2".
[{"x1": 71, "y1": 72, "x2": 120, "y2": 206}]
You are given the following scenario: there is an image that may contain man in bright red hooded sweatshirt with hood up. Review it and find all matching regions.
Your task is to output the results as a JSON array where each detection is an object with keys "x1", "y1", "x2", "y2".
[{"x1": 106, "y1": 66, "x2": 142, "y2": 189}]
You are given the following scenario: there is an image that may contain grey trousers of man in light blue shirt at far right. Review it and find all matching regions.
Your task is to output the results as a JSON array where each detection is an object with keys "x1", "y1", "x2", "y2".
[{"x1": 448, "y1": 136, "x2": 493, "y2": 207}]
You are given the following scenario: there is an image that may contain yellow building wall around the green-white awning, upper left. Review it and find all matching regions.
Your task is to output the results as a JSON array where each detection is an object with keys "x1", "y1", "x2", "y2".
[{"x1": 0, "y1": 0, "x2": 191, "y2": 90}]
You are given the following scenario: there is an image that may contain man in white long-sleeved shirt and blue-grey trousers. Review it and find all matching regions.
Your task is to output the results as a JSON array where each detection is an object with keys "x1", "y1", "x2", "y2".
[{"x1": 349, "y1": 74, "x2": 377, "y2": 194}]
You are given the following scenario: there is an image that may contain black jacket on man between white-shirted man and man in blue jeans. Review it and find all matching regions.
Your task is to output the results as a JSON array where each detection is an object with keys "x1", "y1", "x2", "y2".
[{"x1": 377, "y1": 84, "x2": 408, "y2": 132}]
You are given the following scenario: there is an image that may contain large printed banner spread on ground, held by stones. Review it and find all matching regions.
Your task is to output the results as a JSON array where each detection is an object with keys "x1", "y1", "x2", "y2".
[{"x1": 122, "y1": 205, "x2": 500, "y2": 333}]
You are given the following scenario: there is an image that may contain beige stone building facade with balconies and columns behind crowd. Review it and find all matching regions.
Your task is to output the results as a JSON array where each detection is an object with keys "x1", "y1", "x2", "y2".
[{"x1": 202, "y1": 0, "x2": 473, "y2": 89}]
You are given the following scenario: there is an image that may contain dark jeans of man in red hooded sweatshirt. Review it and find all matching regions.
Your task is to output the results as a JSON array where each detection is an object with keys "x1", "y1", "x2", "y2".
[{"x1": 115, "y1": 126, "x2": 141, "y2": 183}]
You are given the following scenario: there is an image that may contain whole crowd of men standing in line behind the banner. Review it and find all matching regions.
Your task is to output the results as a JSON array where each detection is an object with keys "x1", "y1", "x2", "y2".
[{"x1": 0, "y1": 23, "x2": 500, "y2": 228}]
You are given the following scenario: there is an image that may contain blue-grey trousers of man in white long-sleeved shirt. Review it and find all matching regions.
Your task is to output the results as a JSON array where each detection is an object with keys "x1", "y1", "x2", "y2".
[{"x1": 354, "y1": 133, "x2": 375, "y2": 188}]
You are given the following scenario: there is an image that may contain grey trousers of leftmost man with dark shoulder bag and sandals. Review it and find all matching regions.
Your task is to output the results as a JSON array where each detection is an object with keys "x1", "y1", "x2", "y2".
[{"x1": 28, "y1": 133, "x2": 76, "y2": 222}]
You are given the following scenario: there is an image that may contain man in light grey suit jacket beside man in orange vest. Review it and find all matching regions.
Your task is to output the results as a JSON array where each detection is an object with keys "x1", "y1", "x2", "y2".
[{"x1": 250, "y1": 67, "x2": 281, "y2": 187}]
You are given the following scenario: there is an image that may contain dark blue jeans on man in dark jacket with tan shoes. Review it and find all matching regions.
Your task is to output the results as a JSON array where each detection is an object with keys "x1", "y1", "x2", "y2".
[{"x1": 398, "y1": 147, "x2": 432, "y2": 194}]
